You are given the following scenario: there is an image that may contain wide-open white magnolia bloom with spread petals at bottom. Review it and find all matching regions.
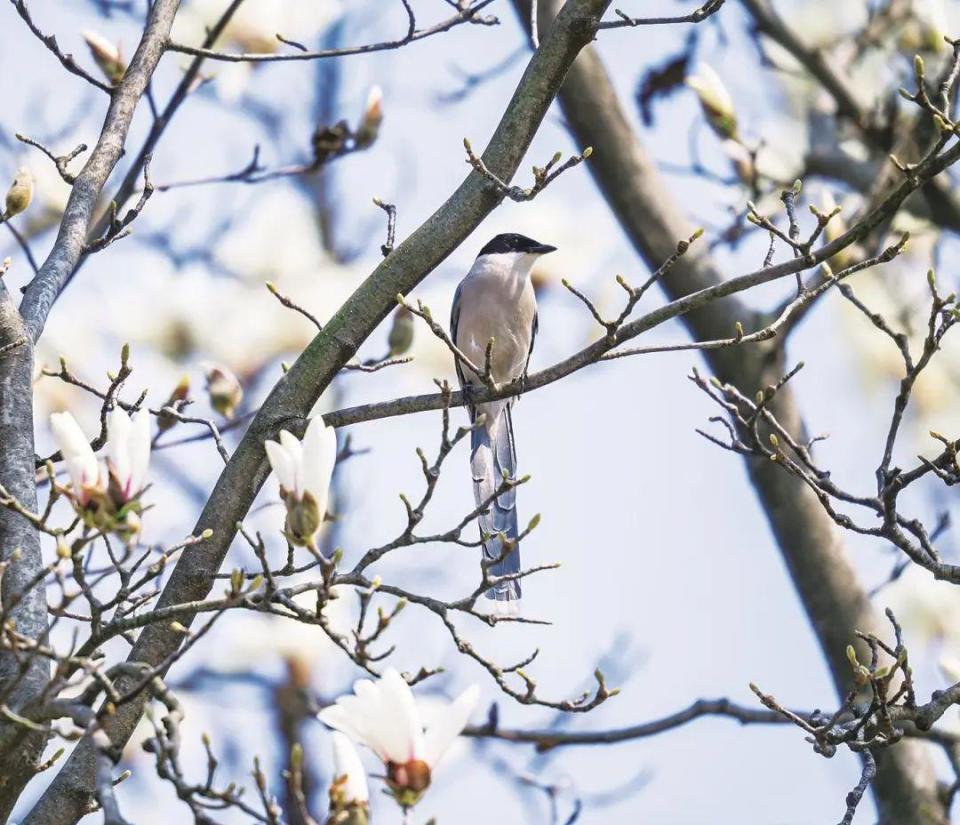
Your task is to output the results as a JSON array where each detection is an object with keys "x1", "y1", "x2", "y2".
[{"x1": 318, "y1": 668, "x2": 480, "y2": 808}]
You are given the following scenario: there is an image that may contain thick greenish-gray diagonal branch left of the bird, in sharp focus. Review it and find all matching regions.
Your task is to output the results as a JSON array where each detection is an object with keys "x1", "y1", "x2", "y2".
[{"x1": 24, "y1": 0, "x2": 609, "y2": 825}]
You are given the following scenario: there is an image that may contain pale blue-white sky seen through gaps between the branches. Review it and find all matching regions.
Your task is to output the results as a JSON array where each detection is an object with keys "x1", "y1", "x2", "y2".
[{"x1": 0, "y1": 0, "x2": 960, "y2": 825}]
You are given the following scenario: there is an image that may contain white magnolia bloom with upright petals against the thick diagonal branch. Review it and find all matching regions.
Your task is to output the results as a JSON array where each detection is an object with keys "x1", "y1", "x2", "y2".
[{"x1": 263, "y1": 416, "x2": 337, "y2": 547}]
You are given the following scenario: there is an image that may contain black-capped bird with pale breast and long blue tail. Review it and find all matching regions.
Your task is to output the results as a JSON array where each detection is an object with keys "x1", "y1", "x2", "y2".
[{"x1": 450, "y1": 233, "x2": 556, "y2": 612}]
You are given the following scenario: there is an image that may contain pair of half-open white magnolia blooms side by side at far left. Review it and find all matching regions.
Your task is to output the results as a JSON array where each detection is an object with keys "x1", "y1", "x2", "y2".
[{"x1": 50, "y1": 406, "x2": 150, "y2": 538}]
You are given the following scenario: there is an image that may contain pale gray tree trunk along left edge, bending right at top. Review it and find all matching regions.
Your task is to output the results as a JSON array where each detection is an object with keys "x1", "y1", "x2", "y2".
[{"x1": 0, "y1": 0, "x2": 180, "y2": 821}]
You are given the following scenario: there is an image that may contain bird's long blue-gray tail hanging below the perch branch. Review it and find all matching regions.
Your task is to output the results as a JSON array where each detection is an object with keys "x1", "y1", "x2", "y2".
[{"x1": 470, "y1": 406, "x2": 520, "y2": 602}]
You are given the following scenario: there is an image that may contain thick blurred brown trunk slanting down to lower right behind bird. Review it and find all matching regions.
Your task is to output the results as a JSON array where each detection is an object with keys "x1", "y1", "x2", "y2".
[{"x1": 514, "y1": 0, "x2": 952, "y2": 825}]
